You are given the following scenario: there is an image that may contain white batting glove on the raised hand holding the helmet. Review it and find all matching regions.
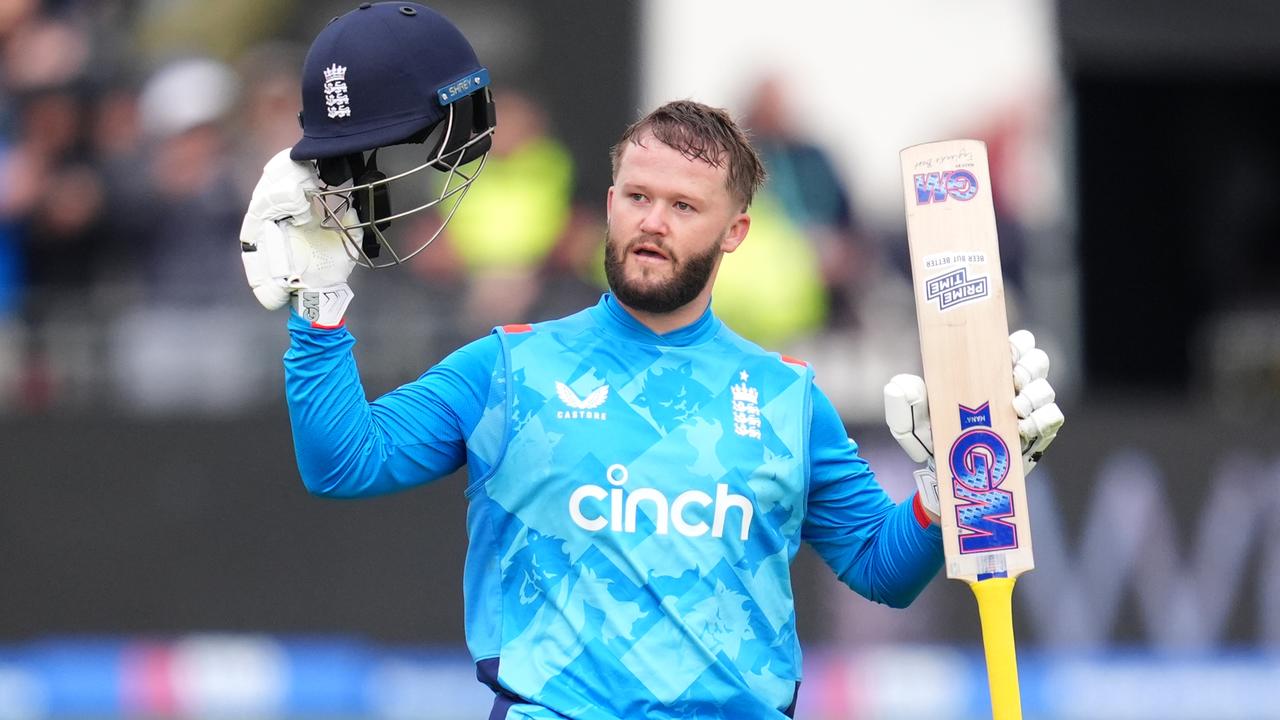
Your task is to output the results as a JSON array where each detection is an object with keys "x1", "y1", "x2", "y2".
[{"x1": 241, "y1": 149, "x2": 362, "y2": 327}]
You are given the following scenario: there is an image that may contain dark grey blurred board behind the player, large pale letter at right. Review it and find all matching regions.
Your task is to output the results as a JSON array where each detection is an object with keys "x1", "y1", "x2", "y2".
[{"x1": 0, "y1": 406, "x2": 1280, "y2": 650}]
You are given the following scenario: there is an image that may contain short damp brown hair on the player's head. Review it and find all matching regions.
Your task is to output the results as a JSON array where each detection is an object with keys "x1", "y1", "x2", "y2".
[{"x1": 612, "y1": 100, "x2": 764, "y2": 210}]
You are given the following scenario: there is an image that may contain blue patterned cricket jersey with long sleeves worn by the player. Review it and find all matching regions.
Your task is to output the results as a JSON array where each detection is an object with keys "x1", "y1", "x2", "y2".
[{"x1": 284, "y1": 289, "x2": 942, "y2": 720}]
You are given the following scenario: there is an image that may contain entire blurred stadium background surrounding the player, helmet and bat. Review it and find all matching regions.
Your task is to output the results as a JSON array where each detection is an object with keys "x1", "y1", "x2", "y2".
[{"x1": 0, "y1": 0, "x2": 1280, "y2": 719}]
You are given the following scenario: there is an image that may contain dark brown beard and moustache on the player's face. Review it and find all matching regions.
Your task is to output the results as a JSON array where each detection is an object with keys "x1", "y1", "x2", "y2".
[{"x1": 604, "y1": 231, "x2": 721, "y2": 314}]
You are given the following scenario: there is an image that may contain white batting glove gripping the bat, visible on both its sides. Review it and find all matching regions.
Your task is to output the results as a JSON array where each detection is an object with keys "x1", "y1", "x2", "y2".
[{"x1": 884, "y1": 331, "x2": 1064, "y2": 518}]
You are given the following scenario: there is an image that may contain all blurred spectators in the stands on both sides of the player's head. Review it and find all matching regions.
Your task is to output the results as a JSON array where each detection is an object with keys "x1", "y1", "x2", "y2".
[{"x1": 0, "y1": 0, "x2": 942, "y2": 414}]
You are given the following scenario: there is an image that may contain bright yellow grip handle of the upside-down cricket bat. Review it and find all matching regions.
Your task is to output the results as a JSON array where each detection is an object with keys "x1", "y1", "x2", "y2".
[{"x1": 969, "y1": 578, "x2": 1023, "y2": 720}]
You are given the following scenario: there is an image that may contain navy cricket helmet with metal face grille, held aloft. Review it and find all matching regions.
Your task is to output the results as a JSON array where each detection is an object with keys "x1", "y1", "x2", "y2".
[{"x1": 289, "y1": 3, "x2": 495, "y2": 268}]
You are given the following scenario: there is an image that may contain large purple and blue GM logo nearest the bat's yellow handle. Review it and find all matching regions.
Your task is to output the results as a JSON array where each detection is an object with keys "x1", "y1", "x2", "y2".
[{"x1": 947, "y1": 402, "x2": 1018, "y2": 553}]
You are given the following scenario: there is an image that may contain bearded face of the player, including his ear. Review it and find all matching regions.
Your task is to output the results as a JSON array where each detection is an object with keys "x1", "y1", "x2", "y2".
[{"x1": 604, "y1": 135, "x2": 750, "y2": 313}]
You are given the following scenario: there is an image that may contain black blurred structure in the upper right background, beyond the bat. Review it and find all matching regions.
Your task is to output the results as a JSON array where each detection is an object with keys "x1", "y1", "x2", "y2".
[{"x1": 1059, "y1": 0, "x2": 1280, "y2": 394}]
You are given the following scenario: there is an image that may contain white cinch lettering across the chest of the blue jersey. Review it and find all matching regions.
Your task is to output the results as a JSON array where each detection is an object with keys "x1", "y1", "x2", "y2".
[{"x1": 568, "y1": 464, "x2": 755, "y2": 541}]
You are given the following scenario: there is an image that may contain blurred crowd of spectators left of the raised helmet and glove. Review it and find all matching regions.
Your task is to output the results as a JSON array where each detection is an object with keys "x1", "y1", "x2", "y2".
[{"x1": 0, "y1": 0, "x2": 314, "y2": 411}]
